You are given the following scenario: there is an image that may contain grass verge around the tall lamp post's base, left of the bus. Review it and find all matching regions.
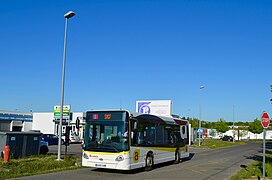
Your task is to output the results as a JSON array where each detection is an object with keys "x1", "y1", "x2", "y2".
[{"x1": 0, "y1": 155, "x2": 79, "y2": 180}]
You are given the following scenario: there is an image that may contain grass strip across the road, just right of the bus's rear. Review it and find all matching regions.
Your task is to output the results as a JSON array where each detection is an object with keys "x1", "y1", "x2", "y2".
[{"x1": 191, "y1": 139, "x2": 245, "y2": 148}]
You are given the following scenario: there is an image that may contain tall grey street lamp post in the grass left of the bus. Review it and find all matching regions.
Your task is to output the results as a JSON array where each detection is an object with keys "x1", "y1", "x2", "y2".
[{"x1": 57, "y1": 11, "x2": 75, "y2": 160}]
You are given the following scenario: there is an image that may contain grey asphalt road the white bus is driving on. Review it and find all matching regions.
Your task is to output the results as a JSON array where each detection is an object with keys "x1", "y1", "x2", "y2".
[{"x1": 9, "y1": 142, "x2": 262, "y2": 180}]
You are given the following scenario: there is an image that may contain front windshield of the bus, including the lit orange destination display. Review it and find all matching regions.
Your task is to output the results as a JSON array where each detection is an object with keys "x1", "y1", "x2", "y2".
[{"x1": 84, "y1": 112, "x2": 129, "y2": 152}]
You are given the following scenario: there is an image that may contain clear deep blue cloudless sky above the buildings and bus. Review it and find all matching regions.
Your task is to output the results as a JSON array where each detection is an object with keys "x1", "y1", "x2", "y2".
[{"x1": 0, "y1": 0, "x2": 272, "y2": 122}]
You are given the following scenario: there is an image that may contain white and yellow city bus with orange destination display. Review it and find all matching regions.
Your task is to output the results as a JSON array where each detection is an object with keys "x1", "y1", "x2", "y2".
[{"x1": 82, "y1": 110, "x2": 189, "y2": 171}]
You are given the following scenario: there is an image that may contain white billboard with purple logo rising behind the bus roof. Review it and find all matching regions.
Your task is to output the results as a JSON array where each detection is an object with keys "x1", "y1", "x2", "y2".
[{"x1": 136, "y1": 100, "x2": 172, "y2": 116}]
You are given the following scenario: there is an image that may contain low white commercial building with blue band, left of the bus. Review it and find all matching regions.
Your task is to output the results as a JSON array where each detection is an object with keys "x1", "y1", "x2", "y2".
[{"x1": 0, "y1": 111, "x2": 85, "y2": 139}]
